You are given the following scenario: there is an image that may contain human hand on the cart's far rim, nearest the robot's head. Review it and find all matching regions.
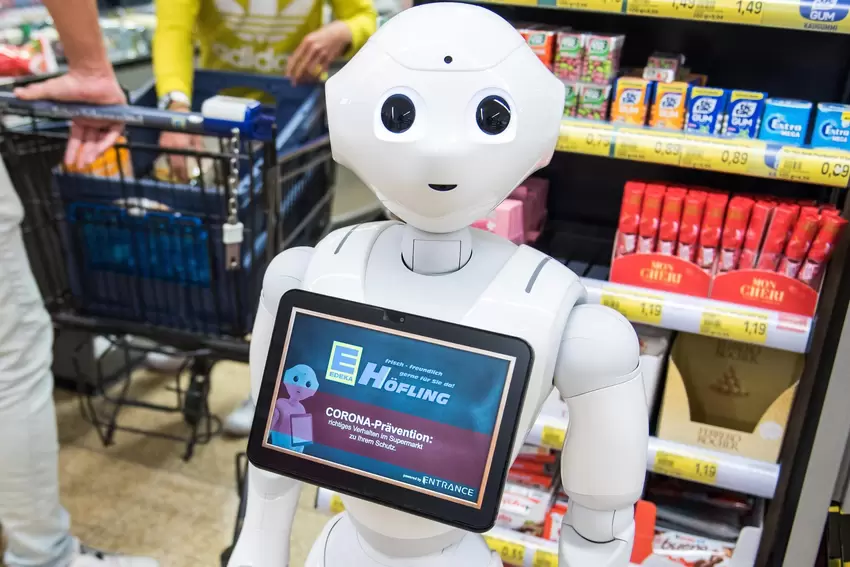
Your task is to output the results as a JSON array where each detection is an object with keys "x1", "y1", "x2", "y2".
[{"x1": 286, "y1": 20, "x2": 351, "y2": 85}]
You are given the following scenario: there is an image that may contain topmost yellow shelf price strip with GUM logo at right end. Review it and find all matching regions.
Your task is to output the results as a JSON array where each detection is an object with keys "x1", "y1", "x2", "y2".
[{"x1": 481, "y1": 0, "x2": 850, "y2": 34}]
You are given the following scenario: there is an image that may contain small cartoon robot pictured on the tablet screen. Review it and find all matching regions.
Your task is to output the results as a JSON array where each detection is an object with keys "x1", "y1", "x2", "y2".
[{"x1": 269, "y1": 364, "x2": 319, "y2": 453}]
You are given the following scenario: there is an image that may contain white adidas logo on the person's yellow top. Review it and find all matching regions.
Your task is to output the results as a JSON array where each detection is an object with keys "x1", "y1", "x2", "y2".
[{"x1": 215, "y1": 0, "x2": 316, "y2": 43}]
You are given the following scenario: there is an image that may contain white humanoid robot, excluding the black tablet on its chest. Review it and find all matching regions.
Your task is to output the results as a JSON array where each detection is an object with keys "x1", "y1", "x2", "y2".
[{"x1": 229, "y1": 3, "x2": 648, "y2": 567}]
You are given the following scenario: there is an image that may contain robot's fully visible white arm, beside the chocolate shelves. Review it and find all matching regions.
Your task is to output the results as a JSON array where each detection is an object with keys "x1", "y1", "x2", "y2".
[{"x1": 555, "y1": 305, "x2": 649, "y2": 567}]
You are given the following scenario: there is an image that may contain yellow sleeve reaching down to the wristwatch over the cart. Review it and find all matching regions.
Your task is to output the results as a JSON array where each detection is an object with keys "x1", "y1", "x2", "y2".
[{"x1": 152, "y1": 0, "x2": 201, "y2": 105}]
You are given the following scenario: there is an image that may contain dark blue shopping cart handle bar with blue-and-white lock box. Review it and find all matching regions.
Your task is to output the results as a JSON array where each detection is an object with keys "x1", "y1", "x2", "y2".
[{"x1": 0, "y1": 92, "x2": 275, "y2": 142}]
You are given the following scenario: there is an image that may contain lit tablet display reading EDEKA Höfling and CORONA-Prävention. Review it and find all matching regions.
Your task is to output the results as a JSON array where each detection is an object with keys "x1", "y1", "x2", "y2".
[{"x1": 263, "y1": 307, "x2": 516, "y2": 509}]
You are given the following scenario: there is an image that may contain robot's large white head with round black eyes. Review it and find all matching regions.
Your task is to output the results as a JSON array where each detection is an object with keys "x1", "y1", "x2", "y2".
[{"x1": 326, "y1": 2, "x2": 564, "y2": 233}]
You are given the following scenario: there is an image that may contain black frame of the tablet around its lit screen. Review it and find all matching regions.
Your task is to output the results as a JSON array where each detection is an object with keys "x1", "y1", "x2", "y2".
[{"x1": 248, "y1": 290, "x2": 534, "y2": 533}]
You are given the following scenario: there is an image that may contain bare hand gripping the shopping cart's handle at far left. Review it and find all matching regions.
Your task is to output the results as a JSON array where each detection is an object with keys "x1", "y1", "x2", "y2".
[{"x1": 15, "y1": 70, "x2": 127, "y2": 169}]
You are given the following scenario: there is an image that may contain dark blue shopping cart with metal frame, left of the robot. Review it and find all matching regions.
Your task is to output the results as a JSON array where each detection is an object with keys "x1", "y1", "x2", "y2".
[{"x1": 0, "y1": 71, "x2": 334, "y2": 459}]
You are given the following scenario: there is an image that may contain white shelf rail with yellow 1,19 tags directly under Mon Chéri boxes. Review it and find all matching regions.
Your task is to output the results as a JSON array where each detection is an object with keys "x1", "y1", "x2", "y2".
[{"x1": 582, "y1": 278, "x2": 812, "y2": 353}]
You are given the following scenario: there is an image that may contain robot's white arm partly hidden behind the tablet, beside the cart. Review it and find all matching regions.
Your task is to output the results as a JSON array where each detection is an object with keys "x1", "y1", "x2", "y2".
[{"x1": 228, "y1": 247, "x2": 313, "y2": 567}]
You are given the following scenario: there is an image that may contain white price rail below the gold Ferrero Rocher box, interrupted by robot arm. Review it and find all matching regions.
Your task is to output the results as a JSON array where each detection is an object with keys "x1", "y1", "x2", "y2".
[{"x1": 525, "y1": 415, "x2": 779, "y2": 498}]
